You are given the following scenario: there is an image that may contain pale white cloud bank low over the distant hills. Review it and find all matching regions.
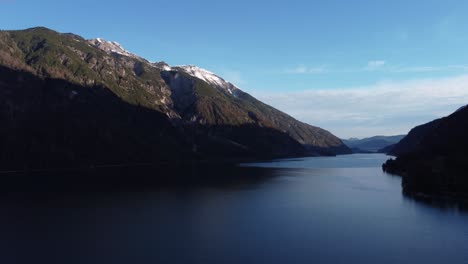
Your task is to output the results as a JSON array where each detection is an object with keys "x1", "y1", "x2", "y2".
[{"x1": 254, "y1": 75, "x2": 468, "y2": 137}]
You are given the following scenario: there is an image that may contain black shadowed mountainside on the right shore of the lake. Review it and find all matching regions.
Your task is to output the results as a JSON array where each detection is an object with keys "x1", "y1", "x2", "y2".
[{"x1": 383, "y1": 107, "x2": 468, "y2": 201}]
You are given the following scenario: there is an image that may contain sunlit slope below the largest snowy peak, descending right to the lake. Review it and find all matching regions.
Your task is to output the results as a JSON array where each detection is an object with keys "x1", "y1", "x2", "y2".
[{"x1": 161, "y1": 66, "x2": 350, "y2": 155}]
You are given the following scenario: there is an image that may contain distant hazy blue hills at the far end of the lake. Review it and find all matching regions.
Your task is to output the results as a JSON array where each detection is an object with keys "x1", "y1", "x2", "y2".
[{"x1": 342, "y1": 135, "x2": 404, "y2": 153}]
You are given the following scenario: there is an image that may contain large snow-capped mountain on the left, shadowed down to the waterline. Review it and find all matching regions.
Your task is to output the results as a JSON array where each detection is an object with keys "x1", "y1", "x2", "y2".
[{"x1": 0, "y1": 27, "x2": 350, "y2": 169}]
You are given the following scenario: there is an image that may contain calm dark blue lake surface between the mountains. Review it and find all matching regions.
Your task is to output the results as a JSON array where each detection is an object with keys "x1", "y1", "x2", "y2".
[{"x1": 0, "y1": 154, "x2": 468, "y2": 264}]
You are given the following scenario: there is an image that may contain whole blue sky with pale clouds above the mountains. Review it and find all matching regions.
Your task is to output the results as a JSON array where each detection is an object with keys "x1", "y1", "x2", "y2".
[{"x1": 0, "y1": 0, "x2": 468, "y2": 137}]
